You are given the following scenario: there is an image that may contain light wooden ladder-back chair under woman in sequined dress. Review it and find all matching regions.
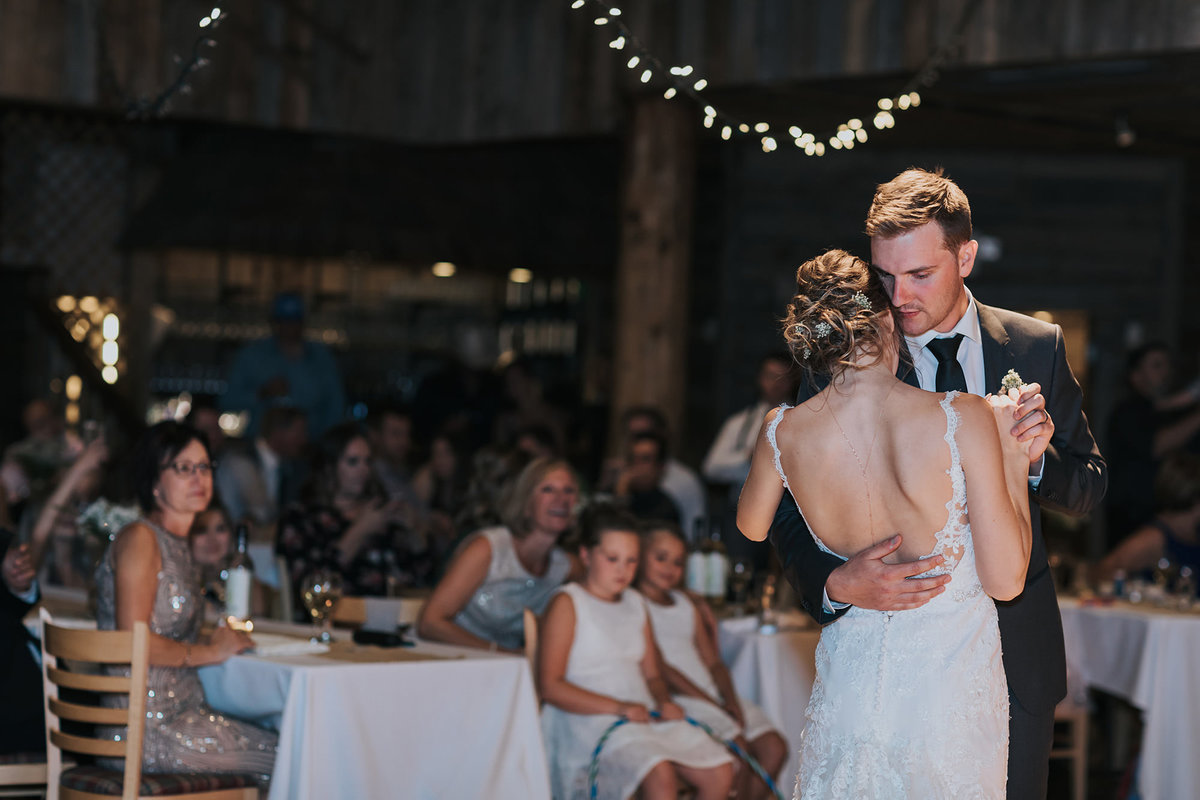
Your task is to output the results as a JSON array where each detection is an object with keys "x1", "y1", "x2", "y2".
[{"x1": 42, "y1": 609, "x2": 258, "y2": 800}]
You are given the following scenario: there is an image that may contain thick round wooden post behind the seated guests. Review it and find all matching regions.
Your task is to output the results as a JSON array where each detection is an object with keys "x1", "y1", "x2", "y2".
[{"x1": 610, "y1": 97, "x2": 700, "y2": 445}]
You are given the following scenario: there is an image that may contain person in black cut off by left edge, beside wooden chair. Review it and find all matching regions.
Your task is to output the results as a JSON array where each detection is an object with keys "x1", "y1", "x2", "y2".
[{"x1": 0, "y1": 528, "x2": 46, "y2": 756}]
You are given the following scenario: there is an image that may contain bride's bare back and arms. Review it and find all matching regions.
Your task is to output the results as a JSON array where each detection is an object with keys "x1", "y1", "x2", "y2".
[{"x1": 738, "y1": 371, "x2": 1028, "y2": 599}]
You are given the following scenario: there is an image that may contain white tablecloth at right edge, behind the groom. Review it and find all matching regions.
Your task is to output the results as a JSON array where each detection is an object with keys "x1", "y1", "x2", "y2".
[{"x1": 1060, "y1": 600, "x2": 1200, "y2": 800}]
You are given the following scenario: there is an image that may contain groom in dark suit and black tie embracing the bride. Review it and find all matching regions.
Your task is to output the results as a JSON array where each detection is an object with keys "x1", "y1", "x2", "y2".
[{"x1": 770, "y1": 169, "x2": 1108, "y2": 800}]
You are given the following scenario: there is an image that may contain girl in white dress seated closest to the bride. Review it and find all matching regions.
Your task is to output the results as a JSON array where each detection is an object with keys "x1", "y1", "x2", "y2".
[{"x1": 637, "y1": 523, "x2": 787, "y2": 800}]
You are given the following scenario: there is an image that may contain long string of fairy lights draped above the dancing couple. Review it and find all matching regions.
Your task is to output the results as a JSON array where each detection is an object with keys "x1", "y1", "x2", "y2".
[{"x1": 571, "y1": 0, "x2": 982, "y2": 157}]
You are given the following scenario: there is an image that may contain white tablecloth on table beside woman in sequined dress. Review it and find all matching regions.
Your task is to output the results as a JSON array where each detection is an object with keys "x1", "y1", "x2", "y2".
[{"x1": 199, "y1": 643, "x2": 550, "y2": 800}]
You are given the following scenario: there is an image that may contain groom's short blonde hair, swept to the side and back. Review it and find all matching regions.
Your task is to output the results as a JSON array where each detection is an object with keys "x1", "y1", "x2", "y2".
[{"x1": 866, "y1": 167, "x2": 971, "y2": 253}]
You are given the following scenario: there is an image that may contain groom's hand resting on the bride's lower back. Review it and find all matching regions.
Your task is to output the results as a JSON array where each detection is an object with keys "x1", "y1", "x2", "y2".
[{"x1": 826, "y1": 534, "x2": 950, "y2": 612}]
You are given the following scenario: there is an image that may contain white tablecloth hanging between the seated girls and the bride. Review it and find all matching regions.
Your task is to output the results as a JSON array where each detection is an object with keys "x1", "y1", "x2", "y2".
[{"x1": 719, "y1": 614, "x2": 821, "y2": 796}]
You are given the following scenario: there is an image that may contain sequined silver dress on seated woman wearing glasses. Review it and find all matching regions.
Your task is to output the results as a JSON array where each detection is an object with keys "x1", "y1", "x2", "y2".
[{"x1": 96, "y1": 519, "x2": 277, "y2": 780}]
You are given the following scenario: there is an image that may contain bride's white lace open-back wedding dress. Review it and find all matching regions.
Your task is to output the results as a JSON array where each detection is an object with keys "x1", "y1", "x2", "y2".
[{"x1": 767, "y1": 392, "x2": 1008, "y2": 800}]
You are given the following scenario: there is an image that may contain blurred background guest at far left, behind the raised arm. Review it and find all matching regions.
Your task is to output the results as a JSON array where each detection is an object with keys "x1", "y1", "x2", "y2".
[{"x1": 0, "y1": 398, "x2": 83, "y2": 534}]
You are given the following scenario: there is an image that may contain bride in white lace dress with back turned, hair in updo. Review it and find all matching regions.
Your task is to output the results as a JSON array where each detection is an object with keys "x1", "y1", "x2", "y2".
[{"x1": 738, "y1": 249, "x2": 1031, "y2": 800}]
